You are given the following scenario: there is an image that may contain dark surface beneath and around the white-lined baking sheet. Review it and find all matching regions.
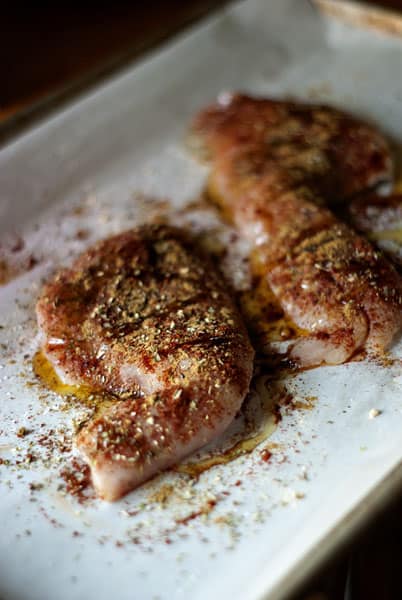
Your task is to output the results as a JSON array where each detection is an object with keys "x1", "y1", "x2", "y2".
[{"x1": 0, "y1": 0, "x2": 402, "y2": 600}]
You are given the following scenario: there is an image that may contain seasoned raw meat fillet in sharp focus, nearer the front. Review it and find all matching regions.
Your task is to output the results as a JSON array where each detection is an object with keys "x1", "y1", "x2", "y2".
[{"x1": 37, "y1": 226, "x2": 254, "y2": 500}]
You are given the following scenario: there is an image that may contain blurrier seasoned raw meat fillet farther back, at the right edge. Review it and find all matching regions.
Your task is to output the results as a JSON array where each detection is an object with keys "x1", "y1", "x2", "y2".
[{"x1": 192, "y1": 96, "x2": 402, "y2": 366}]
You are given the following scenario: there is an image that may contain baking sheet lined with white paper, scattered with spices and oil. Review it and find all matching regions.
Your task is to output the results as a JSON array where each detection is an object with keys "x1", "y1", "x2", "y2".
[{"x1": 0, "y1": 0, "x2": 402, "y2": 600}]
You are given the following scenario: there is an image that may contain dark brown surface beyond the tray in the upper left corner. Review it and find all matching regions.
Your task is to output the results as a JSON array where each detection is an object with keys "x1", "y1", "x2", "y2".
[{"x1": 0, "y1": 0, "x2": 228, "y2": 124}]
